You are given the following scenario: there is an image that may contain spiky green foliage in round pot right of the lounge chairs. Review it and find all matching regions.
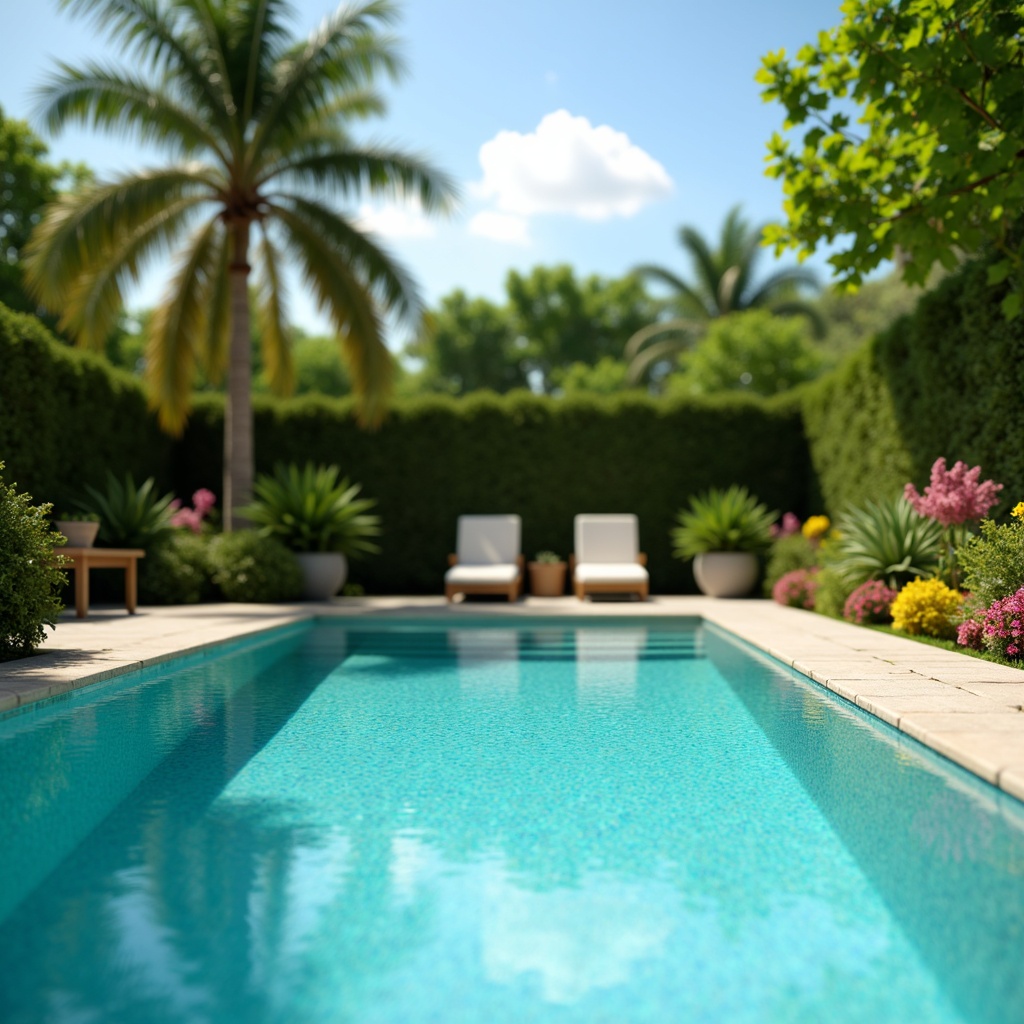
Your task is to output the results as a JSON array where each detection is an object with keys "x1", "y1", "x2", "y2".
[{"x1": 672, "y1": 484, "x2": 778, "y2": 559}]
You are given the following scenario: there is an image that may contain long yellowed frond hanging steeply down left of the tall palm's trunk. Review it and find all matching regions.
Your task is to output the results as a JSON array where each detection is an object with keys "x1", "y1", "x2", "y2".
[{"x1": 145, "y1": 220, "x2": 224, "y2": 434}]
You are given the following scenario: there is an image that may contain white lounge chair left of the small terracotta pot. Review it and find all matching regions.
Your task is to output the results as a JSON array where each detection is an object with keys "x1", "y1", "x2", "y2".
[{"x1": 444, "y1": 515, "x2": 523, "y2": 601}]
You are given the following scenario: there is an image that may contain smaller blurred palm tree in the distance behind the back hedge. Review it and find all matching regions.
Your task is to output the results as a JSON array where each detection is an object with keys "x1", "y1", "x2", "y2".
[{"x1": 625, "y1": 206, "x2": 823, "y2": 383}]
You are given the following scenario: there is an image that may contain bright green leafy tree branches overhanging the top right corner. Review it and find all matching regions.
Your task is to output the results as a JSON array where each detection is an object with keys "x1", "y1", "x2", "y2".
[{"x1": 758, "y1": 0, "x2": 1024, "y2": 316}]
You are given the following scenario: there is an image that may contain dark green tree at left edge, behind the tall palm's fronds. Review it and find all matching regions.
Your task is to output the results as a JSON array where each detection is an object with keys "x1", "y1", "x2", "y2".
[{"x1": 0, "y1": 108, "x2": 91, "y2": 313}]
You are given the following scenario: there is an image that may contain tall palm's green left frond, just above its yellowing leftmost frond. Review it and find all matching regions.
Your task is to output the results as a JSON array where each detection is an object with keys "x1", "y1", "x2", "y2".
[{"x1": 36, "y1": 62, "x2": 226, "y2": 159}]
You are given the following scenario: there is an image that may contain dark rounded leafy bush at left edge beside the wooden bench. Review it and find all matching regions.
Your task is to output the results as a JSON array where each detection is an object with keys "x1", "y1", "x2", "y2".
[{"x1": 0, "y1": 462, "x2": 65, "y2": 662}]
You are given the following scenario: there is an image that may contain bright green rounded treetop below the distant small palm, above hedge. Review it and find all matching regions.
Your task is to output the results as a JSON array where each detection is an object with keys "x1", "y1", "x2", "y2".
[{"x1": 666, "y1": 309, "x2": 824, "y2": 395}]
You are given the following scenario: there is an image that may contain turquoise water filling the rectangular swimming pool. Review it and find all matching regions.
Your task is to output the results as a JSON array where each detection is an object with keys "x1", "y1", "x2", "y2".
[{"x1": 0, "y1": 620, "x2": 1024, "y2": 1024}]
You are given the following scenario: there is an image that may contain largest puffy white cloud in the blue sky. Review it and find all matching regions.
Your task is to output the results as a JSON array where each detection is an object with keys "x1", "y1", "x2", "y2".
[{"x1": 474, "y1": 111, "x2": 672, "y2": 220}]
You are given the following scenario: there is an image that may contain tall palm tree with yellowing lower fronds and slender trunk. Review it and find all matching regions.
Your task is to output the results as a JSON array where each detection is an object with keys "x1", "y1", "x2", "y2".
[{"x1": 27, "y1": 0, "x2": 455, "y2": 524}]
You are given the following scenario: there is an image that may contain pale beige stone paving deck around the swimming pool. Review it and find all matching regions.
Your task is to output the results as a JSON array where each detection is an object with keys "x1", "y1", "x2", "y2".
[{"x1": 0, "y1": 597, "x2": 1024, "y2": 800}]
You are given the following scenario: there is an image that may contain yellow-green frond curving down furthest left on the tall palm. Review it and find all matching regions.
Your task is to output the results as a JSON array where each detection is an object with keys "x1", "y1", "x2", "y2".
[{"x1": 25, "y1": 164, "x2": 216, "y2": 310}]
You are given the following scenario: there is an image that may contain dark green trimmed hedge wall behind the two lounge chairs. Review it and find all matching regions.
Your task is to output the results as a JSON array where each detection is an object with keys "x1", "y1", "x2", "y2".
[{"x1": 174, "y1": 392, "x2": 810, "y2": 593}]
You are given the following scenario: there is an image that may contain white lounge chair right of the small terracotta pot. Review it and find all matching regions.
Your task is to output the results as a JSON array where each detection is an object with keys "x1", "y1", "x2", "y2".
[{"x1": 569, "y1": 514, "x2": 650, "y2": 601}]
